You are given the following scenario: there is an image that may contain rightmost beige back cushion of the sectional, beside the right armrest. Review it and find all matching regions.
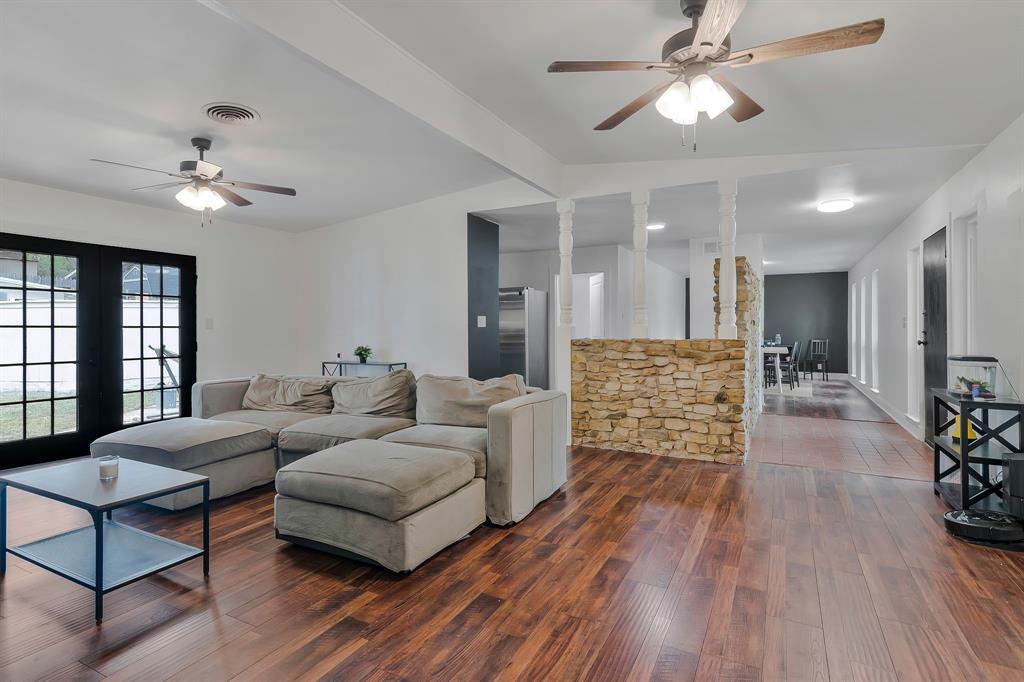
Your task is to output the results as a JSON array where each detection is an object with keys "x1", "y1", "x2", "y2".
[{"x1": 416, "y1": 374, "x2": 526, "y2": 427}]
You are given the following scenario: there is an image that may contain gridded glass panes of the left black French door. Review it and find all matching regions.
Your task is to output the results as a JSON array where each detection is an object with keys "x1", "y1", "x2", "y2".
[{"x1": 0, "y1": 250, "x2": 78, "y2": 440}]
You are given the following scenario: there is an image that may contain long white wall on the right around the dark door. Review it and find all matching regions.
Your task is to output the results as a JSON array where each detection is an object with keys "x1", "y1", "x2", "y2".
[{"x1": 850, "y1": 117, "x2": 1024, "y2": 435}]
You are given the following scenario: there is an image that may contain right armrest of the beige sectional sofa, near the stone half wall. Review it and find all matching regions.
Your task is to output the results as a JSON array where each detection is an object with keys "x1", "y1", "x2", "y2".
[{"x1": 485, "y1": 391, "x2": 568, "y2": 525}]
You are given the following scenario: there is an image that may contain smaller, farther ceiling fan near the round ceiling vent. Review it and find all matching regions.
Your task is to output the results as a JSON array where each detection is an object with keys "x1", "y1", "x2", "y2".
[{"x1": 89, "y1": 137, "x2": 295, "y2": 220}]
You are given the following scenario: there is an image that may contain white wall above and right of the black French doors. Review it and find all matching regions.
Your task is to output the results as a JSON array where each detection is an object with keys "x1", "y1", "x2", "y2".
[{"x1": 0, "y1": 179, "x2": 301, "y2": 379}]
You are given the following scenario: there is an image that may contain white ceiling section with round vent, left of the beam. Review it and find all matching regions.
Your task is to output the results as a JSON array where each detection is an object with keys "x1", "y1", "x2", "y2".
[{"x1": 0, "y1": 0, "x2": 507, "y2": 231}]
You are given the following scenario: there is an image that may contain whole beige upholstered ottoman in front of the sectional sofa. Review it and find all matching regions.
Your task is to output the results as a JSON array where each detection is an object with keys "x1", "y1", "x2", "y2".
[{"x1": 273, "y1": 440, "x2": 484, "y2": 572}]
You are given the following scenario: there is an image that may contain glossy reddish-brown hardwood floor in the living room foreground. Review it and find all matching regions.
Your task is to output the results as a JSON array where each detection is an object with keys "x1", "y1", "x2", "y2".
[{"x1": 0, "y1": 417, "x2": 1024, "y2": 682}]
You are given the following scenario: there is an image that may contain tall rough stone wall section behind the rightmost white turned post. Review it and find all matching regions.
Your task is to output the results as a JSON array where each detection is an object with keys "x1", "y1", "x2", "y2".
[{"x1": 715, "y1": 256, "x2": 764, "y2": 434}]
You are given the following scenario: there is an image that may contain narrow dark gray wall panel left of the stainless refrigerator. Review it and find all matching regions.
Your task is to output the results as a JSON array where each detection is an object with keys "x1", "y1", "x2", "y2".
[{"x1": 466, "y1": 215, "x2": 501, "y2": 379}]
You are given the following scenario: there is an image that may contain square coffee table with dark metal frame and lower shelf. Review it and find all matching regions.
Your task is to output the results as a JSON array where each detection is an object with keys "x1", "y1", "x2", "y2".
[{"x1": 0, "y1": 459, "x2": 210, "y2": 623}]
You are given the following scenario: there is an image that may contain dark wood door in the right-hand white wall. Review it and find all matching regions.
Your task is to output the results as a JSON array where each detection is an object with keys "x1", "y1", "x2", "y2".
[{"x1": 919, "y1": 227, "x2": 946, "y2": 442}]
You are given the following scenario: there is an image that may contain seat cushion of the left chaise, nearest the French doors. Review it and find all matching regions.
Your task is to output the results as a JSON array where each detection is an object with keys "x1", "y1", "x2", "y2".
[{"x1": 89, "y1": 417, "x2": 271, "y2": 470}]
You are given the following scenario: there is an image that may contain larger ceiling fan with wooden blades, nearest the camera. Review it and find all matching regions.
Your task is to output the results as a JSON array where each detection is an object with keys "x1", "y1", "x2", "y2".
[{"x1": 548, "y1": 0, "x2": 886, "y2": 139}]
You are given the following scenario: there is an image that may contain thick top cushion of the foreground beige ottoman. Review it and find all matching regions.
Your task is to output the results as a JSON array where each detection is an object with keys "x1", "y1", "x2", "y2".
[{"x1": 276, "y1": 440, "x2": 473, "y2": 521}]
